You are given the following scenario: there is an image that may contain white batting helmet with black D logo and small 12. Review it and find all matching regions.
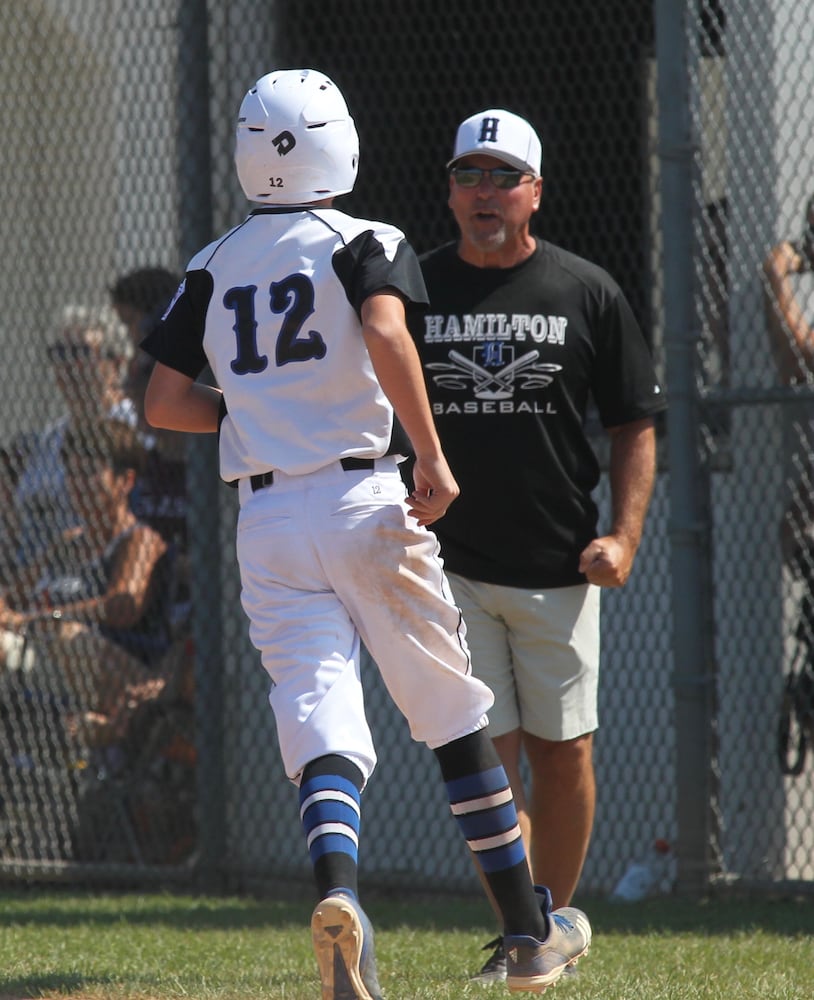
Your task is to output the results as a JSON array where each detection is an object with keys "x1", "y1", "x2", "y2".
[{"x1": 235, "y1": 69, "x2": 359, "y2": 205}]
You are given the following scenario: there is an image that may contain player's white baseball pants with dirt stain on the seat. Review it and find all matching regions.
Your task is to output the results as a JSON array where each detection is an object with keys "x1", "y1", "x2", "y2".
[{"x1": 237, "y1": 458, "x2": 493, "y2": 782}]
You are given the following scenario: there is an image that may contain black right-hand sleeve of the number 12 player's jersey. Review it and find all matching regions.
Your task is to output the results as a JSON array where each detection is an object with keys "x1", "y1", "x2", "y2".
[{"x1": 333, "y1": 229, "x2": 428, "y2": 316}]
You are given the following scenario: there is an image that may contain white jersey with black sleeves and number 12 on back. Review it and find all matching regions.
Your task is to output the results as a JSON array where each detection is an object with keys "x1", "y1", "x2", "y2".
[{"x1": 142, "y1": 207, "x2": 427, "y2": 482}]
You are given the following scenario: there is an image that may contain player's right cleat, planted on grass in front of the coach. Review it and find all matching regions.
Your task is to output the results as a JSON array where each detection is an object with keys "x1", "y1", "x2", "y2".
[{"x1": 503, "y1": 886, "x2": 592, "y2": 993}]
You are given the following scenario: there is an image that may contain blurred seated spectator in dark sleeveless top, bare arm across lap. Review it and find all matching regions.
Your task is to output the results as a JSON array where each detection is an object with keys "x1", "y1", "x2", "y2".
[{"x1": 0, "y1": 420, "x2": 170, "y2": 714}]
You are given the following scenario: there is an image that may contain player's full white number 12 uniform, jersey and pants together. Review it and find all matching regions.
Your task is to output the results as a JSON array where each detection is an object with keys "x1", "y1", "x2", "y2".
[{"x1": 142, "y1": 207, "x2": 493, "y2": 782}]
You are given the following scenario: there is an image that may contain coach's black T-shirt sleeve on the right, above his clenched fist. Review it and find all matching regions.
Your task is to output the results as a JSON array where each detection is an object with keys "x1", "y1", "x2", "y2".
[{"x1": 591, "y1": 288, "x2": 666, "y2": 427}]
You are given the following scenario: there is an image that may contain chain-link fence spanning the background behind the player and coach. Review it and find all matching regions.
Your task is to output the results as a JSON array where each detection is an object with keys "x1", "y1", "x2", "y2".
[{"x1": 0, "y1": 0, "x2": 814, "y2": 893}]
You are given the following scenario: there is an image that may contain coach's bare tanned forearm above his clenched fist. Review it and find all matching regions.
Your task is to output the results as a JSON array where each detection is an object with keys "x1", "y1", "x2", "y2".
[{"x1": 610, "y1": 419, "x2": 656, "y2": 552}]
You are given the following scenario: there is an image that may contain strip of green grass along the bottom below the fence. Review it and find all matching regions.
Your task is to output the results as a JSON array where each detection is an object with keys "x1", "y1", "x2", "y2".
[{"x1": 0, "y1": 889, "x2": 814, "y2": 1000}]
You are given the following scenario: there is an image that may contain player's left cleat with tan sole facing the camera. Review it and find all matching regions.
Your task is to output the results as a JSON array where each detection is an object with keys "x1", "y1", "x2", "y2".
[{"x1": 311, "y1": 893, "x2": 382, "y2": 1000}]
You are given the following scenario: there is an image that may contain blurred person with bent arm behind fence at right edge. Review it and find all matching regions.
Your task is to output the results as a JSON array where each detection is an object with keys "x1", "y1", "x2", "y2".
[{"x1": 763, "y1": 197, "x2": 814, "y2": 580}]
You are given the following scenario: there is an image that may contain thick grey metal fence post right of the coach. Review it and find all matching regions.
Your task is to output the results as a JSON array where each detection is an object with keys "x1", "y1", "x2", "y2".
[{"x1": 655, "y1": 0, "x2": 716, "y2": 892}]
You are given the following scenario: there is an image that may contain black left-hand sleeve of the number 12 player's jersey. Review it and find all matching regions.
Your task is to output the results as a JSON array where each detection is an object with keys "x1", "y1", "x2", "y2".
[{"x1": 140, "y1": 270, "x2": 213, "y2": 379}]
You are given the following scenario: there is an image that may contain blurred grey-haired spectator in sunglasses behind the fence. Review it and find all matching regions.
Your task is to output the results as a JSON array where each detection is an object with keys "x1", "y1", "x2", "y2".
[{"x1": 0, "y1": 306, "x2": 137, "y2": 577}]
